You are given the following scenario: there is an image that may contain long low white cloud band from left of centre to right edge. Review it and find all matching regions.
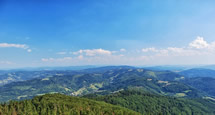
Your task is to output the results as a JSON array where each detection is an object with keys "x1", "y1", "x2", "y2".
[{"x1": 41, "y1": 37, "x2": 215, "y2": 65}]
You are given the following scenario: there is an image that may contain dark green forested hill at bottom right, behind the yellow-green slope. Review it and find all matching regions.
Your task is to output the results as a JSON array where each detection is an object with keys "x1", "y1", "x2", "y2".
[{"x1": 85, "y1": 90, "x2": 215, "y2": 115}]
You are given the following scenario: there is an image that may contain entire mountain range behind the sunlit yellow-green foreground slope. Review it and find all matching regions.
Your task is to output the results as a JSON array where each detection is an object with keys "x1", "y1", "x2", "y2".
[{"x1": 0, "y1": 66, "x2": 215, "y2": 114}]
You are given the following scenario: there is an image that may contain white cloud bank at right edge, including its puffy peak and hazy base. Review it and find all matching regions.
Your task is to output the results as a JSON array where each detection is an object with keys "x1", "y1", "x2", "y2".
[{"x1": 136, "y1": 37, "x2": 215, "y2": 64}]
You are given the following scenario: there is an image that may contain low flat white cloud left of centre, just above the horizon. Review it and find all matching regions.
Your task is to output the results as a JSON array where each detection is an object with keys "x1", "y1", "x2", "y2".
[{"x1": 41, "y1": 49, "x2": 124, "y2": 64}]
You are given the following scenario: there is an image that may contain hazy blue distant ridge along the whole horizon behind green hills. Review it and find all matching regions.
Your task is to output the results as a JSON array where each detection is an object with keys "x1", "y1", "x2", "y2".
[{"x1": 0, "y1": 66, "x2": 215, "y2": 85}]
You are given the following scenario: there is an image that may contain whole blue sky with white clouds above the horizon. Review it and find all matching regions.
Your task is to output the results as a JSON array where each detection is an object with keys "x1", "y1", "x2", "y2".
[{"x1": 0, "y1": 0, "x2": 215, "y2": 68}]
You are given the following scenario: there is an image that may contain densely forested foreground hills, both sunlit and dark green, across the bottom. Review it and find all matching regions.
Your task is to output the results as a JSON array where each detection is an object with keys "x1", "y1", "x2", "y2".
[{"x1": 0, "y1": 89, "x2": 215, "y2": 115}]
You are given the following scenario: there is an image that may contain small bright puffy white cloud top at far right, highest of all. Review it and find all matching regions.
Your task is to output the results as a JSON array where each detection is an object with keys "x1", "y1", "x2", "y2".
[{"x1": 189, "y1": 36, "x2": 209, "y2": 49}]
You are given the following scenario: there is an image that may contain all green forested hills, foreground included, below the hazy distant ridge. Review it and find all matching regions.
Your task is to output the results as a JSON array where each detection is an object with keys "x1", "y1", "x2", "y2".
[{"x1": 0, "y1": 67, "x2": 215, "y2": 115}]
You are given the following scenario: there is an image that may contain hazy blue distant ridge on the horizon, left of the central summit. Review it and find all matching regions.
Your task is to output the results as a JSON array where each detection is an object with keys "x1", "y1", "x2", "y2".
[{"x1": 0, "y1": 66, "x2": 134, "y2": 86}]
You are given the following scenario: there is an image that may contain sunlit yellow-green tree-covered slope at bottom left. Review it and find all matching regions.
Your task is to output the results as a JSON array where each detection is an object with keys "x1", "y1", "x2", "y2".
[{"x1": 0, "y1": 94, "x2": 140, "y2": 115}]
